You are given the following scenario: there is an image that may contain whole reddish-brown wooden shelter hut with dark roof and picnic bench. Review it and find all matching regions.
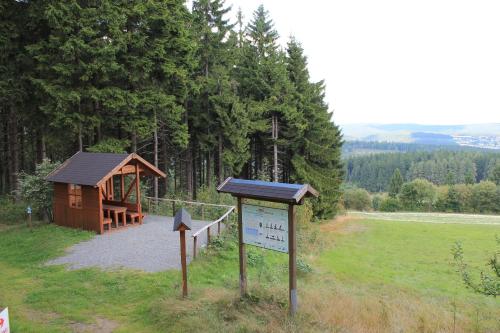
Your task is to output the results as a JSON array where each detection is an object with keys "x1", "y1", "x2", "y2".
[{"x1": 46, "y1": 152, "x2": 165, "y2": 234}]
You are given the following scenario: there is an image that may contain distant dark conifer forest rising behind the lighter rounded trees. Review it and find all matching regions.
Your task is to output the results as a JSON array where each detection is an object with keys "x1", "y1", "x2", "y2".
[{"x1": 345, "y1": 145, "x2": 500, "y2": 192}]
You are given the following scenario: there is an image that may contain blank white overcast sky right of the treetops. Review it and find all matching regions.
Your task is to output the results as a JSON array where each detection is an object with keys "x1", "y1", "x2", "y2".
[{"x1": 220, "y1": 0, "x2": 500, "y2": 125}]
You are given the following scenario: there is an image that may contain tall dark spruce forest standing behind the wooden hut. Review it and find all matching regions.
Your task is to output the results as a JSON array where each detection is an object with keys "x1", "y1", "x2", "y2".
[{"x1": 0, "y1": 0, "x2": 344, "y2": 217}]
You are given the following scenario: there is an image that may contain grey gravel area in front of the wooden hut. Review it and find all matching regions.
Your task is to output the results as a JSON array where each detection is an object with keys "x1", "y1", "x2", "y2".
[{"x1": 47, "y1": 215, "x2": 224, "y2": 272}]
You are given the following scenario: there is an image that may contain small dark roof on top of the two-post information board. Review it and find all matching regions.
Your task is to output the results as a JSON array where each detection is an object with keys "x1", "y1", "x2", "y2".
[{"x1": 217, "y1": 177, "x2": 318, "y2": 204}]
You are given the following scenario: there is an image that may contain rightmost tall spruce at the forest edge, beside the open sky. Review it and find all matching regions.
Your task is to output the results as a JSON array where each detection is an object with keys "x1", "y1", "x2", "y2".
[{"x1": 287, "y1": 39, "x2": 343, "y2": 218}]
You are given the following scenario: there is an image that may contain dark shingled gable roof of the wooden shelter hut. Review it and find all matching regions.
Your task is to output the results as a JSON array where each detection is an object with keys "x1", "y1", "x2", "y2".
[{"x1": 46, "y1": 152, "x2": 165, "y2": 186}]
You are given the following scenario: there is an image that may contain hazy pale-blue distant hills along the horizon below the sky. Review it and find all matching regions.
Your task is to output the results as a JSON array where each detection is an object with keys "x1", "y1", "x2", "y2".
[{"x1": 340, "y1": 123, "x2": 500, "y2": 149}]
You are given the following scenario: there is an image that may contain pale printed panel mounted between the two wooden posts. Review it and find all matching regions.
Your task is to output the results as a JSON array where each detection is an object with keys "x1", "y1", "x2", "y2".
[{"x1": 242, "y1": 204, "x2": 288, "y2": 253}]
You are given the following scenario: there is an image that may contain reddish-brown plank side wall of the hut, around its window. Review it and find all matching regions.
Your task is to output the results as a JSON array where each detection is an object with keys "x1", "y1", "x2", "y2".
[{"x1": 54, "y1": 183, "x2": 101, "y2": 233}]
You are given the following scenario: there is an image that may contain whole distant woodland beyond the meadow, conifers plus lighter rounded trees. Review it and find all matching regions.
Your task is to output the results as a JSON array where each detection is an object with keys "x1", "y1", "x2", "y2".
[{"x1": 342, "y1": 147, "x2": 500, "y2": 213}]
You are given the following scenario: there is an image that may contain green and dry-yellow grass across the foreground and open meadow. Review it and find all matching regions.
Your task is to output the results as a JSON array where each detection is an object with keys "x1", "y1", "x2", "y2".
[{"x1": 0, "y1": 215, "x2": 500, "y2": 333}]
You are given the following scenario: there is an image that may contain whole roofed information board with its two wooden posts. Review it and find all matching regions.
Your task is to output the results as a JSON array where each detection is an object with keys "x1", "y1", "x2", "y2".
[{"x1": 217, "y1": 177, "x2": 318, "y2": 316}]
